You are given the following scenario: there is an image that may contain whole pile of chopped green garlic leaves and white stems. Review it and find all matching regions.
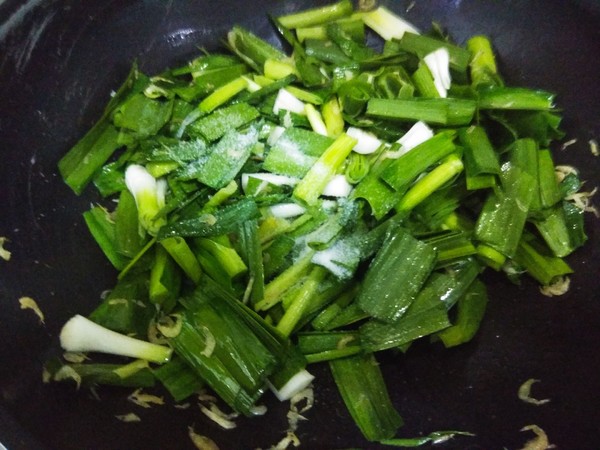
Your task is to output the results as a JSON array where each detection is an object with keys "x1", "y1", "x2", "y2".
[{"x1": 48, "y1": 0, "x2": 586, "y2": 442}]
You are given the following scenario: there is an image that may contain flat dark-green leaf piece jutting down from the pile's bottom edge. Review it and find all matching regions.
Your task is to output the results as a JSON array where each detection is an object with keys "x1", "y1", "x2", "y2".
[{"x1": 329, "y1": 354, "x2": 403, "y2": 442}]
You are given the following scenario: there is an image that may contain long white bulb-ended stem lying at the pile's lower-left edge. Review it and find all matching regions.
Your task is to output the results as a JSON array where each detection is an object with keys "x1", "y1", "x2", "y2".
[{"x1": 60, "y1": 314, "x2": 172, "y2": 363}]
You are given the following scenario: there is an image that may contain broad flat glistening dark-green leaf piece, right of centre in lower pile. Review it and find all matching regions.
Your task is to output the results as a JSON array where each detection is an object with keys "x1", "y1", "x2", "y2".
[{"x1": 357, "y1": 228, "x2": 435, "y2": 322}]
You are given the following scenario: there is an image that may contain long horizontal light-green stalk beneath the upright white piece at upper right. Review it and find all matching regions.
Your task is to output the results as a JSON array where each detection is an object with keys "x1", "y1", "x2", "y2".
[{"x1": 367, "y1": 98, "x2": 477, "y2": 125}]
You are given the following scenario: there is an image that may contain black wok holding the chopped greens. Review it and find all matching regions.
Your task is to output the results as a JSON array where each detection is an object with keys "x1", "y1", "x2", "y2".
[{"x1": 0, "y1": 0, "x2": 600, "y2": 450}]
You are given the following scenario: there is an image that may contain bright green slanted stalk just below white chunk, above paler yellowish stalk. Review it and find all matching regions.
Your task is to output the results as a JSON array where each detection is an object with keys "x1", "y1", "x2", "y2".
[{"x1": 381, "y1": 131, "x2": 456, "y2": 191}]
